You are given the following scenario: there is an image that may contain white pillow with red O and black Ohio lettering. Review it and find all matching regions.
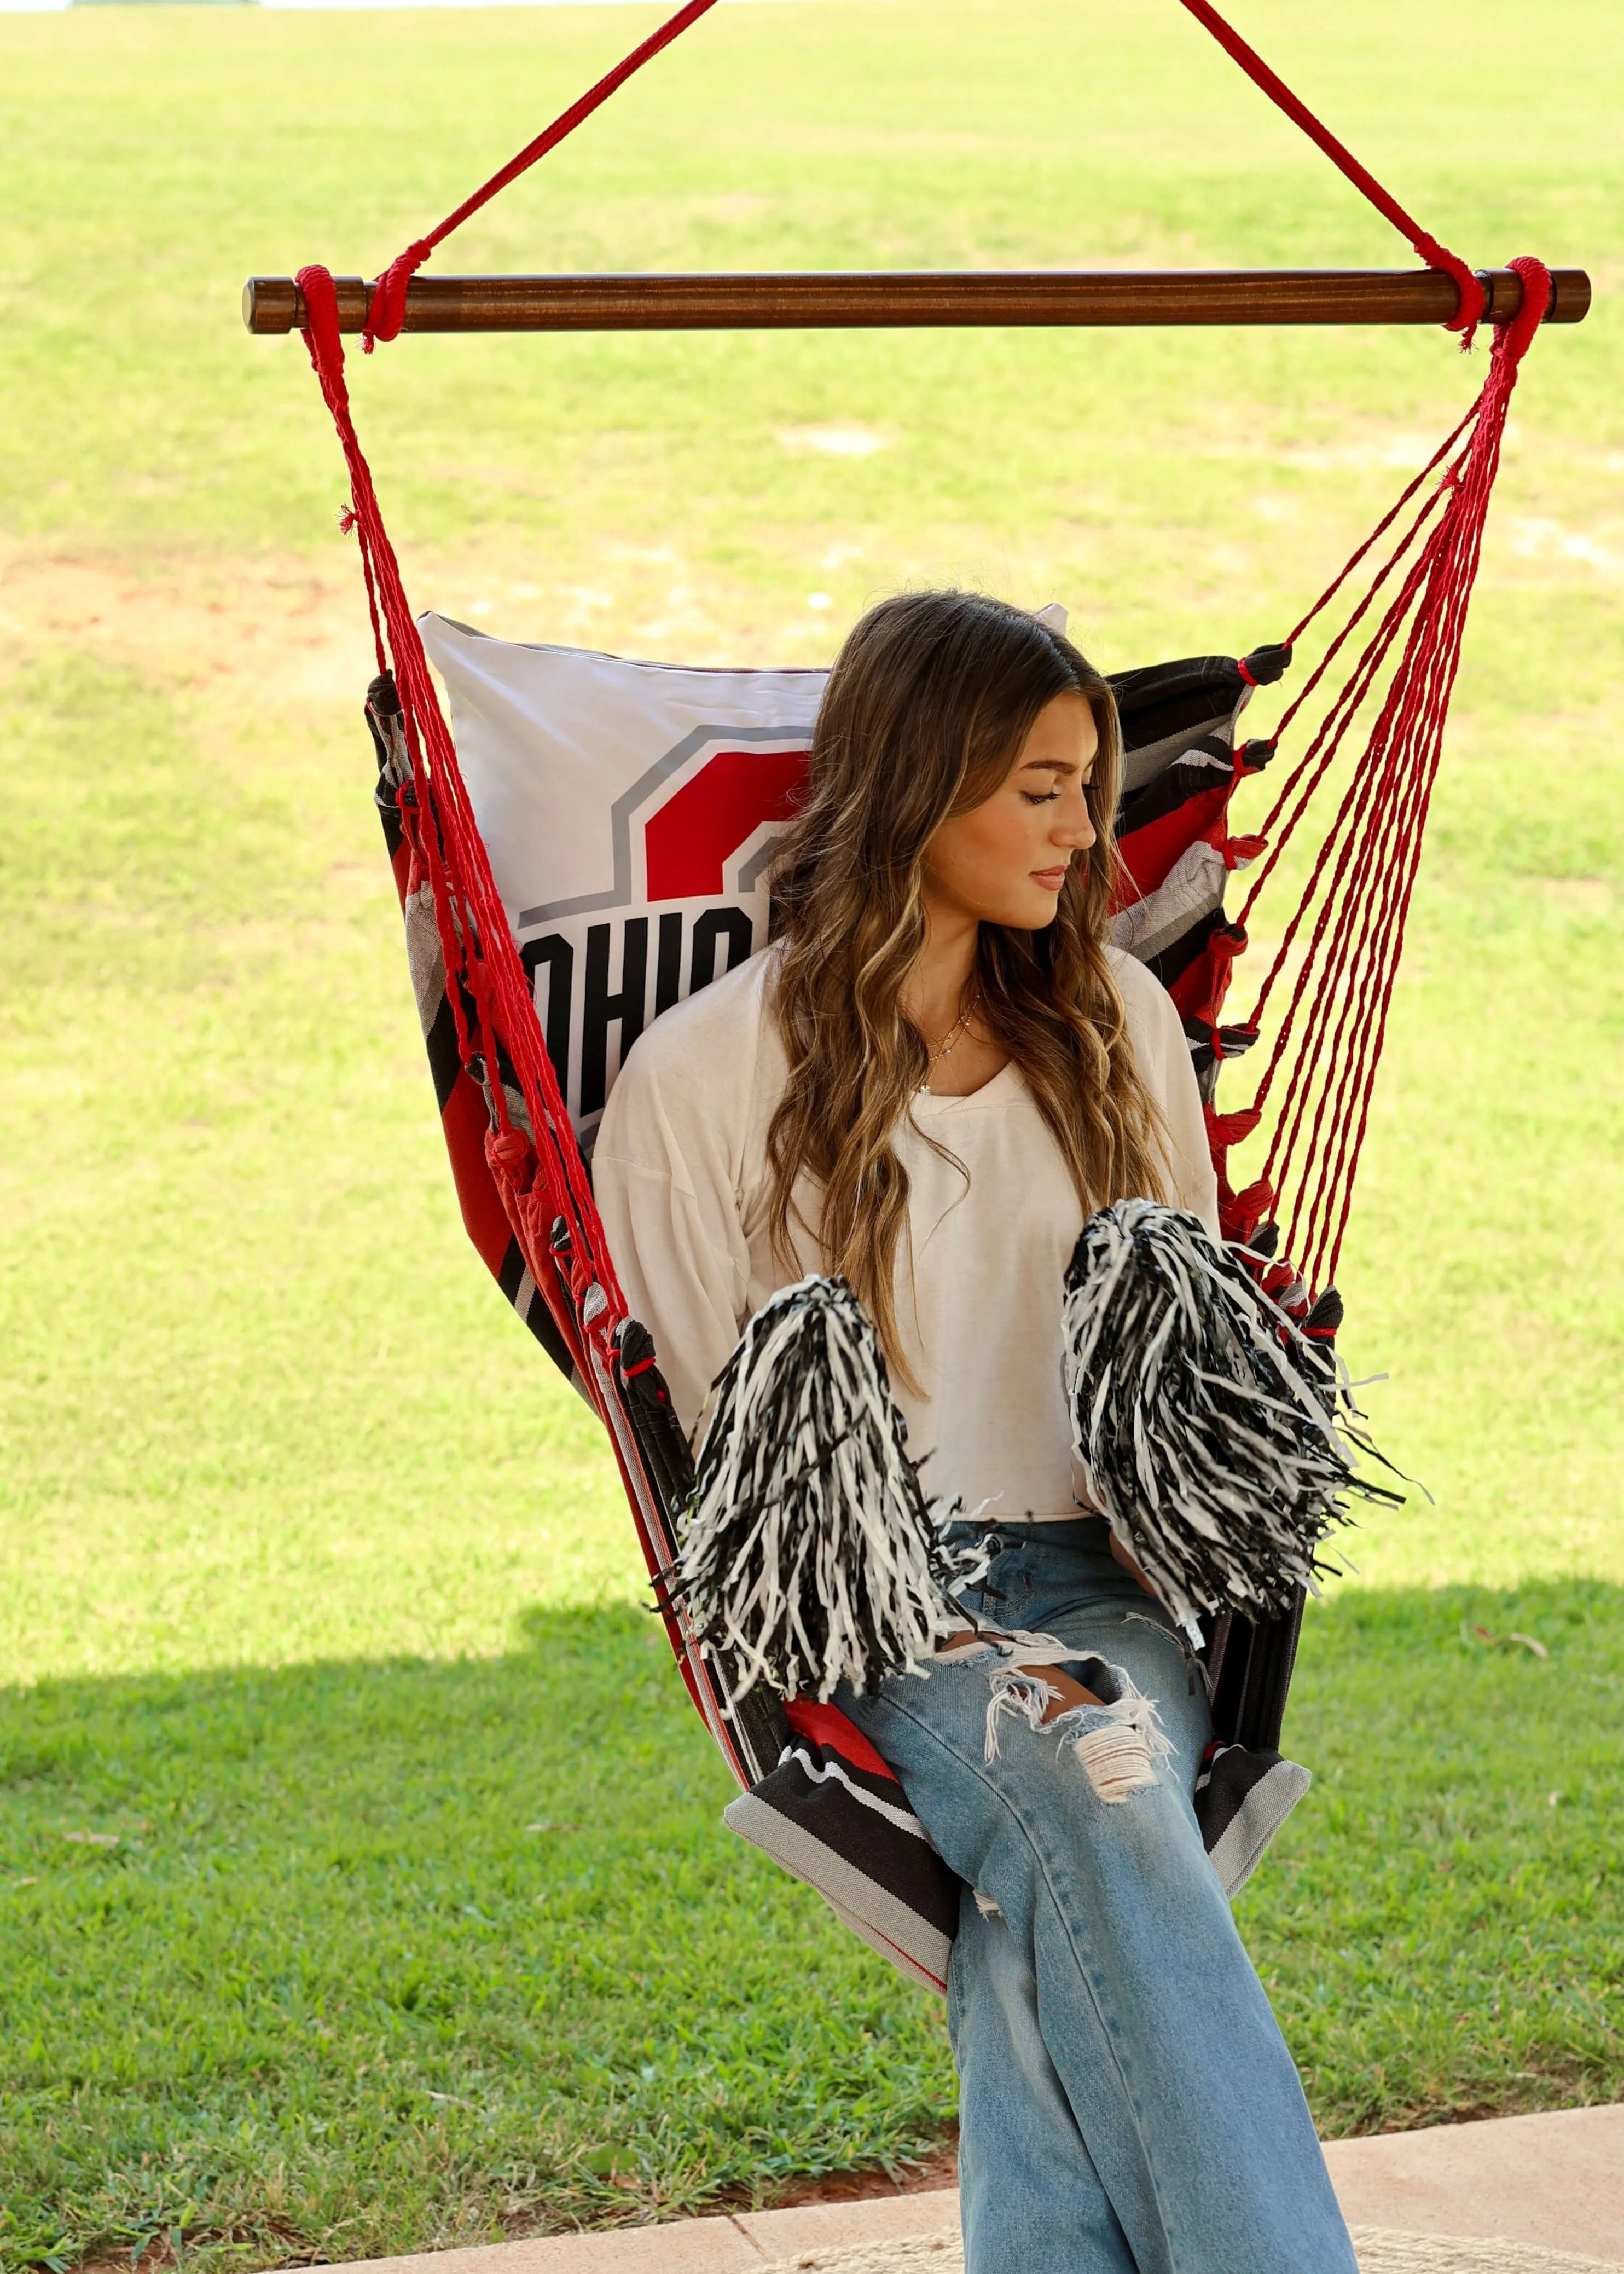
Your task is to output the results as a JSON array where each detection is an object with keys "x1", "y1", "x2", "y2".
[{"x1": 419, "y1": 616, "x2": 828, "y2": 1153}]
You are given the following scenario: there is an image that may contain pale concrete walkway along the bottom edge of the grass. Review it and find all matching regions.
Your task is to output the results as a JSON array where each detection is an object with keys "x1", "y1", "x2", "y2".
[{"x1": 316, "y1": 2108, "x2": 1624, "y2": 2274}]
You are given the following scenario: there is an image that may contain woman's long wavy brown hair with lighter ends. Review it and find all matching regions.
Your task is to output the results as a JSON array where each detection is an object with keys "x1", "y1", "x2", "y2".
[{"x1": 767, "y1": 591, "x2": 1164, "y2": 1390}]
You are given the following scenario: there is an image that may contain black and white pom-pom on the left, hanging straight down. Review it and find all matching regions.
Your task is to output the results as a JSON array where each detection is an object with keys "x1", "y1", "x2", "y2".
[{"x1": 673, "y1": 1276, "x2": 967, "y2": 1699}]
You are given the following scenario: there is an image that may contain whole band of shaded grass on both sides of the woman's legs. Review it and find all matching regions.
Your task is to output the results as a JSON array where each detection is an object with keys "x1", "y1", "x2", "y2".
[{"x1": 0, "y1": 1583, "x2": 1624, "y2": 2265}]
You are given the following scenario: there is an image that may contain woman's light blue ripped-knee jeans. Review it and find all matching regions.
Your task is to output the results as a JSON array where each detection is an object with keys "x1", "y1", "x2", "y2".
[{"x1": 837, "y1": 1517, "x2": 1358, "y2": 2274}]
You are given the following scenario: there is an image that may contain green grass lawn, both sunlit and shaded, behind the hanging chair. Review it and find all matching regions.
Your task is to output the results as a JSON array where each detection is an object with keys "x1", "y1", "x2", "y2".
[{"x1": 0, "y1": 0, "x2": 1624, "y2": 2267}]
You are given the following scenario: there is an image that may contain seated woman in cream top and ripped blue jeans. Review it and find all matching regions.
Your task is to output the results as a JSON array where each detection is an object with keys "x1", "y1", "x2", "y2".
[{"x1": 594, "y1": 593, "x2": 1355, "y2": 2274}]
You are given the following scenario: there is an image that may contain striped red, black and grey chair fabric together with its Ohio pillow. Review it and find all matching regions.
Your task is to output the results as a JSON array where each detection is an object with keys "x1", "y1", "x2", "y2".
[{"x1": 366, "y1": 616, "x2": 1308, "y2": 1990}]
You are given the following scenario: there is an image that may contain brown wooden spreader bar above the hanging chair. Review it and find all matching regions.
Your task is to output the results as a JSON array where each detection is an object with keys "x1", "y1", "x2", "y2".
[{"x1": 243, "y1": 268, "x2": 1590, "y2": 332}]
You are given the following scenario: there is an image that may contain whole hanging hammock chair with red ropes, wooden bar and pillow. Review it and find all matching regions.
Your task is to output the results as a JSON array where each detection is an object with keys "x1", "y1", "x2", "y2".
[{"x1": 243, "y1": 0, "x2": 1590, "y2": 1990}]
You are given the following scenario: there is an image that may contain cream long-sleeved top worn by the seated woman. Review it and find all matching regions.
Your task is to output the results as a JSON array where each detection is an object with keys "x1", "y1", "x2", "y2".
[{"x1": 594, "y1": 948, "x2": 1217, "y2": 1524}]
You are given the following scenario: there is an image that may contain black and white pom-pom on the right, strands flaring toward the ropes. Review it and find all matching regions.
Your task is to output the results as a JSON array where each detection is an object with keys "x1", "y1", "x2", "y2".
[{"x1": 1064, "y1": 1201, "x2": 1396, "y2": 1640}]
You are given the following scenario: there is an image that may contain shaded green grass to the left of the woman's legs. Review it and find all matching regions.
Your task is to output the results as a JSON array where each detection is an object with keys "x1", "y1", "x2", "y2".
[{"x1": 0, "y1": 1608, "x2": 953, "y2": 2263}]
